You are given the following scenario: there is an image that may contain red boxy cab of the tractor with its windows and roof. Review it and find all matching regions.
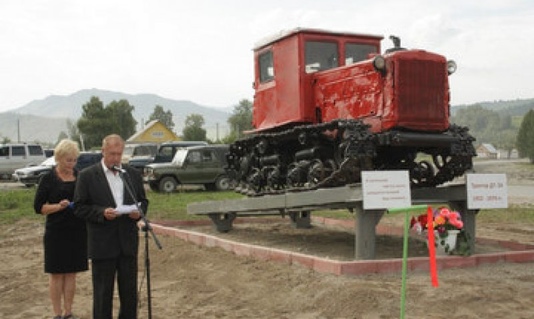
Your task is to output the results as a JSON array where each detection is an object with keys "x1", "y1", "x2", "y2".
[{"x1": 253, "y1": 29, "x2": 383, "y2": 131}]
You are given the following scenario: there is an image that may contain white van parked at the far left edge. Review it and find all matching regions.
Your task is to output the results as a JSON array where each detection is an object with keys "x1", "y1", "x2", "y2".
[{"x1": 0, "y1": 143, "x2": 46, "y2": 179}]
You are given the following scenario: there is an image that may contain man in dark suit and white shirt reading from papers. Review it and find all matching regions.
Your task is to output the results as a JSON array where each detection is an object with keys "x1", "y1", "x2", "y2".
[{"x1": 74, "y1": 134, "x2": 148, "y2": 319}]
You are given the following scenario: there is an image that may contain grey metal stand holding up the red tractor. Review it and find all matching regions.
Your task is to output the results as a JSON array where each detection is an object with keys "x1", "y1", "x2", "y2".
[{"x1": 187, "y1": 184, "x2": 478, "y2": 260}]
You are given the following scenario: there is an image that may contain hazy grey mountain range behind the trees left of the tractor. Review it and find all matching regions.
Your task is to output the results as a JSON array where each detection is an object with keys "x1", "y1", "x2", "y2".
[{"x1": 0, "y1": 89, "x2": 234, "y2": 143}]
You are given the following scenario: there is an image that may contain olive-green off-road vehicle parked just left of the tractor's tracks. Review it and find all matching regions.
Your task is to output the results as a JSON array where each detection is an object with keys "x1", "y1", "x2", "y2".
[{"x1": 143, "y1": 144, "x2": 235, "y2": 193}]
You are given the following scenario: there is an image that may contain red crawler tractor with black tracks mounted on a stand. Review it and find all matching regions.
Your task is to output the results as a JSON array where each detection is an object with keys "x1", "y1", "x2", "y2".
[{"x1": 227, "y1": 29, "x2": 476, "y2": 195}]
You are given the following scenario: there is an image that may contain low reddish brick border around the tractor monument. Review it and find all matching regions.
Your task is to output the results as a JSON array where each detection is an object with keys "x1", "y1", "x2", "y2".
[{"x1": 151, "y1": 217, "x2": 534, "y2": 275}]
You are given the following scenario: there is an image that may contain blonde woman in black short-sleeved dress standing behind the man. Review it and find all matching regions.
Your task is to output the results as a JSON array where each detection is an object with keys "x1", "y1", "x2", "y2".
[{"x1": 34, "y1": 140, "x2": 88, "y2": 319}]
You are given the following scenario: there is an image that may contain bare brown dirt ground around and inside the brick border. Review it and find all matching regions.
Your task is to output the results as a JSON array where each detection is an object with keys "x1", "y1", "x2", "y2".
[{"x1": 0, "y1": 162, "x2": 534, "y2": 319}]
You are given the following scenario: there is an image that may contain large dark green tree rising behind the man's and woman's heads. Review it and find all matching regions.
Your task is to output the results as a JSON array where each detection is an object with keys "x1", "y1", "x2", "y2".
[{"x1": 77, "y1": 96, "x2": 137, "y2": 149}]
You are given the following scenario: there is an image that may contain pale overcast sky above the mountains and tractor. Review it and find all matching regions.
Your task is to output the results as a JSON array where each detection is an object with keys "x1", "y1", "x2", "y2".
[{"x1": 0, "y1": 0, "x2": 534, "y2": 112}]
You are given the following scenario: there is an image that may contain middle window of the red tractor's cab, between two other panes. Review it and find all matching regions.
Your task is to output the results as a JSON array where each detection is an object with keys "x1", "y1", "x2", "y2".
[{"x1": 305, "y1": 41, "x2": 339, "y2": 73}]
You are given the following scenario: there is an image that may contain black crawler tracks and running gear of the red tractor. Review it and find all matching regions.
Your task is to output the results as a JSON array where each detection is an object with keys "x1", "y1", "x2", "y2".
[{"x1": 227, "y1": 120, "x2": 476, "y2": 196}]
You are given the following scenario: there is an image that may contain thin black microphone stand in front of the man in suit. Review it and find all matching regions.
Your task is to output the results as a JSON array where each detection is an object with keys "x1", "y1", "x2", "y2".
[{"x1": 117, "y1": 169, "x2": 162, "y2": 319}]
